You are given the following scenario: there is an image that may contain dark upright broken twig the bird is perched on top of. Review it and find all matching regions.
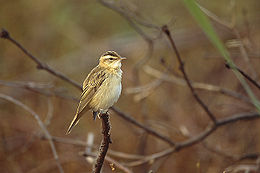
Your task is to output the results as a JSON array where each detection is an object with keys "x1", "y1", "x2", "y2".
[{"x1": 93, "y1": 113, "x2": 112, "y2": 173}]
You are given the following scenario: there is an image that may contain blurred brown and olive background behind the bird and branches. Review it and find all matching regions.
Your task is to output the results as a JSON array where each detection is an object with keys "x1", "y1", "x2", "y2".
[{"x1": 0, "y1": 0, "x2": 260, "y2": 173}]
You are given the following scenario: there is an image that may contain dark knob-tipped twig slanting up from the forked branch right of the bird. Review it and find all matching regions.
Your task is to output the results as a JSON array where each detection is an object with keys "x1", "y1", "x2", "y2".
[{"x1": 162, "y1": 25, "x2": 216, "y2": 123}]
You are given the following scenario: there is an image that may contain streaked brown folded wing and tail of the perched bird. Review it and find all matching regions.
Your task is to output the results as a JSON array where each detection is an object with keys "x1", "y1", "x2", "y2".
[{"x1": 67, "y1": 66, "x2": 107, "y2": 134}]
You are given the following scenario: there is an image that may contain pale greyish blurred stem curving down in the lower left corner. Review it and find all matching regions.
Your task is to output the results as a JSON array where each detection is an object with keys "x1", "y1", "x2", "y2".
[{"x1": 0, "y1": 94, "x2": 64, "y2": 173}]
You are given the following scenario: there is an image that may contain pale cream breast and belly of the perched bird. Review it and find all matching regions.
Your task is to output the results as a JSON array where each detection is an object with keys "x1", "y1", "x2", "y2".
[{"x1": 89, "y1": 76, "x2": 122, "y2": 113}]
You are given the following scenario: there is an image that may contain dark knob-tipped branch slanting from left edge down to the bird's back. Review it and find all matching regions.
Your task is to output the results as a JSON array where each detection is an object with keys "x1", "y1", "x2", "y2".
[{"x1": 0, "y1": 29, "x2": 81, "y2": 89}]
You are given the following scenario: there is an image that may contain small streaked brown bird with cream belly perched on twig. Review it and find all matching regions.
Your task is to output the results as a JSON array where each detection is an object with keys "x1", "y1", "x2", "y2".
[{"x1": 66, "y1": 51, "x2": 126, "y2": 134}]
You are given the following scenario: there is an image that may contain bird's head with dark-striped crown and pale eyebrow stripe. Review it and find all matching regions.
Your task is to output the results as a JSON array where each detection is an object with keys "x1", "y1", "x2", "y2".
[{"x1": 99, "y1": 51, "x2": 126, "y2": 69}]
